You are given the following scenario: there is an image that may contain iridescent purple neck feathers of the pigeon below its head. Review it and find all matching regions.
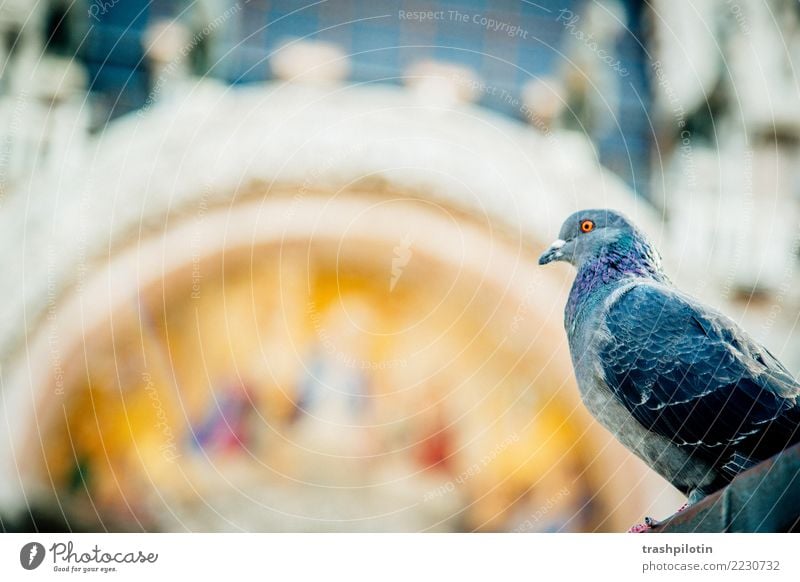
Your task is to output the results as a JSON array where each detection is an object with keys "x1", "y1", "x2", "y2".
[{"x1": 564, "y1": 239, "x2": 669, "y2": 330}]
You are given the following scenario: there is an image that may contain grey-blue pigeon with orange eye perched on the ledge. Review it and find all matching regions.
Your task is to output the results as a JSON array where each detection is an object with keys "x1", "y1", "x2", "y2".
[{"x1": 539, "y1": 209, "x2": 800, "y2": 505}]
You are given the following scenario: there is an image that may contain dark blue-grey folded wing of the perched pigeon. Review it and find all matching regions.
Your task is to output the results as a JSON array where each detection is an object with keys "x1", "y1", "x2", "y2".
[{"x1": 599, "y1": 284, "x2": 800, "y2": 474}]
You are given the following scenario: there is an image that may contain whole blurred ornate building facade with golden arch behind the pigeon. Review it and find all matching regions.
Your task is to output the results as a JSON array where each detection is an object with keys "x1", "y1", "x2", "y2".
[{"x1": 0, "y1": 0, "x2": 800, "y2": 532}]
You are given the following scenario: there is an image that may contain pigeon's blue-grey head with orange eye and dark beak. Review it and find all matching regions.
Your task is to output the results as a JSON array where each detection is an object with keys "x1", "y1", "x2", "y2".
[{"x1": 539, "y1": 209, "x2": 658, "y2": 268}]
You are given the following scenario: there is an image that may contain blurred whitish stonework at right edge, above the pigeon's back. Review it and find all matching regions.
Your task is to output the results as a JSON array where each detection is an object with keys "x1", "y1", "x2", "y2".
[{"x1": 649, "y1": 0, "x2": 800, "y2": 372}]
